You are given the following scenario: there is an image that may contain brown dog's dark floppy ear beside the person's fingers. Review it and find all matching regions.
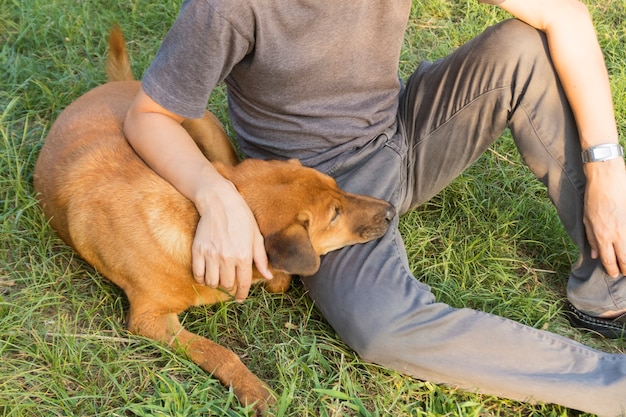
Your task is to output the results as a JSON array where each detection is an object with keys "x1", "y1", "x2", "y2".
[{"x1": 265, "y1": 214, "x2": 320, "y2": 276}]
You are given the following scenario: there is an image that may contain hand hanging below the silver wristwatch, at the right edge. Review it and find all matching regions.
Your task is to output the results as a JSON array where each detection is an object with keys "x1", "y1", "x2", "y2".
[{"x1": 584, "y1": 158, "x2": 626, "y2": 278}]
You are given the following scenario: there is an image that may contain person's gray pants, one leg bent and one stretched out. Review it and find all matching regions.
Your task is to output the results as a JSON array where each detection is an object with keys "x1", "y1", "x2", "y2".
[{"x1": 303, "y1": 20, "x2": 626, "y2": 416}]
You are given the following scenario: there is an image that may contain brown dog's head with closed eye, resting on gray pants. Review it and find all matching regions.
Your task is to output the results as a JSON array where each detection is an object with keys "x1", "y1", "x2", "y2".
[{"x1": 216, "y1": 159, "x2": 395, "y2": 276}]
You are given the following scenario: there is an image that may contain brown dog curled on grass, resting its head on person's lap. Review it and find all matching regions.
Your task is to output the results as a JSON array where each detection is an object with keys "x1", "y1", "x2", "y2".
[{"x1": 34, "y1": 30, "x2": 394, "y2": 413}]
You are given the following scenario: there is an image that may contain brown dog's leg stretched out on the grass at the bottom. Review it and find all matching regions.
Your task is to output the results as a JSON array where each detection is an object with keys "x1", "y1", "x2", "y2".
[{"x1": 128, "y1": 304, "x2": 272, "y2": 416}]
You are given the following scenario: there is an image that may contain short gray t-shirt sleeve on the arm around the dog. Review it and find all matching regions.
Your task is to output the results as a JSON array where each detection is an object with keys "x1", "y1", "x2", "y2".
[{"x1": 142, "y1": 0, "x2": 254, "y2": 118}]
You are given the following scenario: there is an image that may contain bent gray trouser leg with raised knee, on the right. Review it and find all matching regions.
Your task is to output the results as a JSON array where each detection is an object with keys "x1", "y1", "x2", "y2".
[{"x1": 400, "y1": 20, "x2": 626, "y2": 315}]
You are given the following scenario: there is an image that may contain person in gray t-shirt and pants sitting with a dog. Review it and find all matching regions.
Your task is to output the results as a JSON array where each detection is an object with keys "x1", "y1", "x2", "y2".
[{"x1": 125, "y1": 0, "x2": 626, "y2": 416}]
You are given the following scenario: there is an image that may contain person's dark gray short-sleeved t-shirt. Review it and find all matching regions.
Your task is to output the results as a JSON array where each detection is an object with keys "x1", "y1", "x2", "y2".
[{"x1": 143, "y1": 0, "x2": 497, "y2": 166}]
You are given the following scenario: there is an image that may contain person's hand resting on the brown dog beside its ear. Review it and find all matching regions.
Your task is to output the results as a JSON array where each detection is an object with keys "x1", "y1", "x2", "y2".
[{"x1": 192, "y1": 181, "x2": 272, "y2": 302}]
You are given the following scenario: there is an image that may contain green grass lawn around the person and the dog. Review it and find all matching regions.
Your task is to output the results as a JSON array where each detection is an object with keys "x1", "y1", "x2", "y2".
[{"x1": 0, "y1": 0, "x2": 626, "y2": 417}]
